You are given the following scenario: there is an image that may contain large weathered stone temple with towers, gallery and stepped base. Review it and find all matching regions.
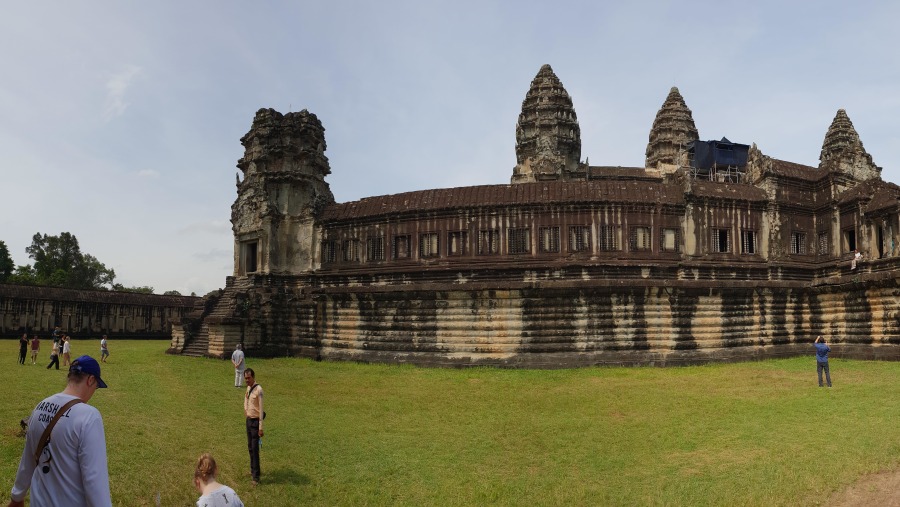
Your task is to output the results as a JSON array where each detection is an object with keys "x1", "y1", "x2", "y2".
[{"x1": 171, "y1": 65, "x2": 900, "y2": 368}]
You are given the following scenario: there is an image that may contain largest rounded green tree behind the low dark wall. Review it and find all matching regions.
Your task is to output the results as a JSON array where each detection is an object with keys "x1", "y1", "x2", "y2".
[{"x1": 25, "y1": 232, "x2": 116, "y2": 289}]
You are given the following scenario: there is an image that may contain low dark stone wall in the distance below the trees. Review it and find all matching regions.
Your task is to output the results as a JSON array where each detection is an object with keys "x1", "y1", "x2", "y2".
[{"x1": 0, "y1": 284, "x2": 198, "y2": 339}]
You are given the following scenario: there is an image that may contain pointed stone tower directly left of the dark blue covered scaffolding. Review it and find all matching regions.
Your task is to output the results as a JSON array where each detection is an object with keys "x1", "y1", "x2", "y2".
[{"x1": 646, "y1": 86, "x2": 700, "y2": 173}]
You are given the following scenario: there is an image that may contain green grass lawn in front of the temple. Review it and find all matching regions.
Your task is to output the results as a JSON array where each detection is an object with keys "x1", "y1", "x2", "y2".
[{"x1": 0, "y1": 340, "x2": 900, "y2": 506}]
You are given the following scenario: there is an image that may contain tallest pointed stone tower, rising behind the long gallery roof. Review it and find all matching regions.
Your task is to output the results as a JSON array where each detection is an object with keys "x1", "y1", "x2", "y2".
[{"x1": 511, "y1": 65, "x2": 586, "y2": 183}]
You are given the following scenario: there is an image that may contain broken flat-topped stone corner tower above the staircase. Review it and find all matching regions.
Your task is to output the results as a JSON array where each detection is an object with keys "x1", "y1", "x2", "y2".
[{"x1": 231, "y1": 109, "x2": 334, "y2": 276}]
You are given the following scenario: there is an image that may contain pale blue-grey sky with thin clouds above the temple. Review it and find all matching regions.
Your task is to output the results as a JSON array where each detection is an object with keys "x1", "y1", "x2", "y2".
[{"x1": 0, "y1": 0, "x2": 900, "y2": 295}]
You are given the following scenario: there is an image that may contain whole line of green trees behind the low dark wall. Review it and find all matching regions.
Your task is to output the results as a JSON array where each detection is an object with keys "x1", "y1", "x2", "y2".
[{"x1": 0, "y1": 232, "x2": 193, "y2": 296}]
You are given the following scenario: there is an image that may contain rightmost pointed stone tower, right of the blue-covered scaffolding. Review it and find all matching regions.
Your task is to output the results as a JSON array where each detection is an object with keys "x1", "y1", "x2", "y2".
[{"x1": 819, "y1": 109, "x2": 881, "y2": 181}]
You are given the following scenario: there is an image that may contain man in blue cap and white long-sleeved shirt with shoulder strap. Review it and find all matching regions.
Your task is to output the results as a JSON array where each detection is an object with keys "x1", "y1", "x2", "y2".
[{"x1": 9, "y1": 356, "x2": 112, "y2": 507}]
